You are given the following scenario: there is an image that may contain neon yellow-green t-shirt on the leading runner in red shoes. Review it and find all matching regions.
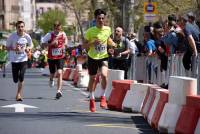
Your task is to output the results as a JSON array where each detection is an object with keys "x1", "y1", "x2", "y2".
[{"x1": 85, "y1": 26, "x2": 111, "y2": 59}]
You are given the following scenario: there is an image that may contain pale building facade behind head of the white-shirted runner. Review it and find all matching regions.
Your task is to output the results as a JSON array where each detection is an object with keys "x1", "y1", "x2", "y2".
[{"x1": 0, "y1": 0, "x2": 36, "y2": 31}]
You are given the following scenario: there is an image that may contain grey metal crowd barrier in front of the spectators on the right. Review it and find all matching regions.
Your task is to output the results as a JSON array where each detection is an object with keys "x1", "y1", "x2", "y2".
[{"x1": 129, "y1": 53, "x2": 200, "y2": 94}]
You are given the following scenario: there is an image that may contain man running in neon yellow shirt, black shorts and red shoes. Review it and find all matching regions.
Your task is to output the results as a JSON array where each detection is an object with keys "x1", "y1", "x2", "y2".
[{"x1": 83, "y1": 9, "x2": 114, "y2": 112}]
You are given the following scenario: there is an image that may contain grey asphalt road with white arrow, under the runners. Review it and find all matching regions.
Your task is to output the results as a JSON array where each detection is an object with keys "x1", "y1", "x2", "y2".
[{"x1": 0, "y1": 66, "x2": 155, "y2": 134}]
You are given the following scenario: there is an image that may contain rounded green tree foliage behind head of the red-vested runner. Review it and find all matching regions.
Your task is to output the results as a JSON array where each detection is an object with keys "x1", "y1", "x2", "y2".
[{"x1": 37, "y1": 9, "x2": 66, "y2": 34}]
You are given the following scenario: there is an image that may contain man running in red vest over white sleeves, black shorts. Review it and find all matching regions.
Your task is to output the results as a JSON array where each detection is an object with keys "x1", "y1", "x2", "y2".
[{"x1": 42, "y1": 21, "x2": 68, "y2": 99}]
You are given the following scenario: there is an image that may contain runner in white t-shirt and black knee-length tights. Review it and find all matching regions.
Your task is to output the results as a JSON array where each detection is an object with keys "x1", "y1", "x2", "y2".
[{"x1": 6, "y1": 21, "x2": 33, "y2": 101}]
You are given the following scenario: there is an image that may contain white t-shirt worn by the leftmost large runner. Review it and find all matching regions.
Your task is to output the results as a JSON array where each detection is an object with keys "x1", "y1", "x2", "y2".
[{"x1": 6, "y1": 32, "x2": 33, "y2": 63}]
